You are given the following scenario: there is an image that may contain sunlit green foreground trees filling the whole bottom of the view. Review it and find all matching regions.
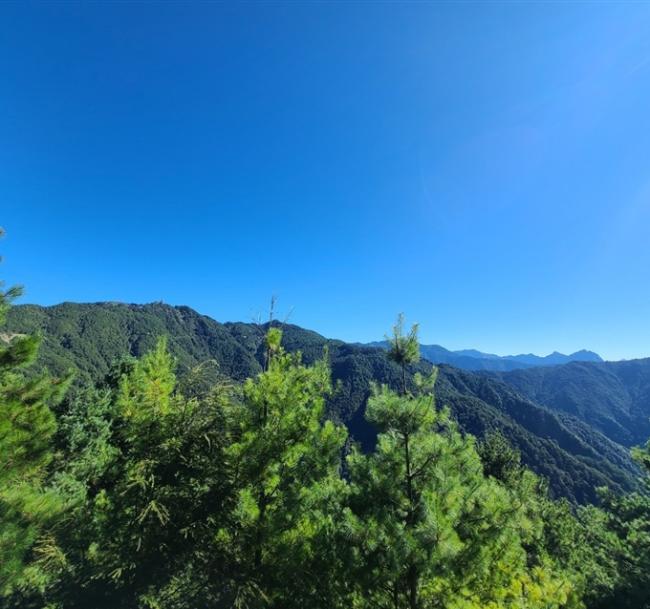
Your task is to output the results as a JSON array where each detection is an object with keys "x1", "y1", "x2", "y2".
[{"x1": 0, "y1": 291, "x2": 650, "y2": 609}]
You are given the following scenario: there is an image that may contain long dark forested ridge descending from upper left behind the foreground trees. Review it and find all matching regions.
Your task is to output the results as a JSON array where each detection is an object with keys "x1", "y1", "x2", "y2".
[{"x1": 4, "y1": 303, "x2": 636, "y2": 502}]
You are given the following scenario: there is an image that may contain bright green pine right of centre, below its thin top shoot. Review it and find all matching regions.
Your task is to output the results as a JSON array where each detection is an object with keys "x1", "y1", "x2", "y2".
[{"x1": 348, "y1": 344, "x2": 572, "y2": 609}]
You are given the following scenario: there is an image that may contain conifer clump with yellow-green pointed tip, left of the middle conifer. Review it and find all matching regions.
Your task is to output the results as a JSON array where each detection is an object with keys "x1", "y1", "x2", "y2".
[{"x1": 41, "y1": 339, "x2": 231, "y2": 609}]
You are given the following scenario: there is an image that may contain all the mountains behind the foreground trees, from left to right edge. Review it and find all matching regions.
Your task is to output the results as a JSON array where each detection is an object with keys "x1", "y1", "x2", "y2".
[{"x1": 0, "y1": 303, "x2": 650, "y2": 502}]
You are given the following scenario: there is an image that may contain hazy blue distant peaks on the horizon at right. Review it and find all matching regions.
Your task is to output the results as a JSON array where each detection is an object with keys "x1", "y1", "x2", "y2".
[{"x1": 365, "y1": 341, "x2": 603, "y2": 372}]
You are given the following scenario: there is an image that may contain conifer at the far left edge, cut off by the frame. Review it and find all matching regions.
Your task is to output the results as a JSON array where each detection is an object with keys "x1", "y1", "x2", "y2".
[{"x1": 0, "y1": 232, "x2": 68, "y2": 594}]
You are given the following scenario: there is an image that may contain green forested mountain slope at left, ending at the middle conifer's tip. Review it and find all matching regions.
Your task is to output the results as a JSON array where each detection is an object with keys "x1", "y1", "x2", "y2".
[{"x1": 6, "y1": 303, "x2": 261, "y2": 380}]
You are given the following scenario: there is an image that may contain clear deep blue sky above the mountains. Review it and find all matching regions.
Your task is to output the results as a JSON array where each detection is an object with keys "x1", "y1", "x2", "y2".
[{"x1": 0, "y1": 2, "x2": 650, "y2": 358}]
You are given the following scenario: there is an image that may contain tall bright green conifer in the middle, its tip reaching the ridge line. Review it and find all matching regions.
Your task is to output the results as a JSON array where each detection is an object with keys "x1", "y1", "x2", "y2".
[{"x1": 218, "y1": 328, "x2": 346, "y2": 609}]
